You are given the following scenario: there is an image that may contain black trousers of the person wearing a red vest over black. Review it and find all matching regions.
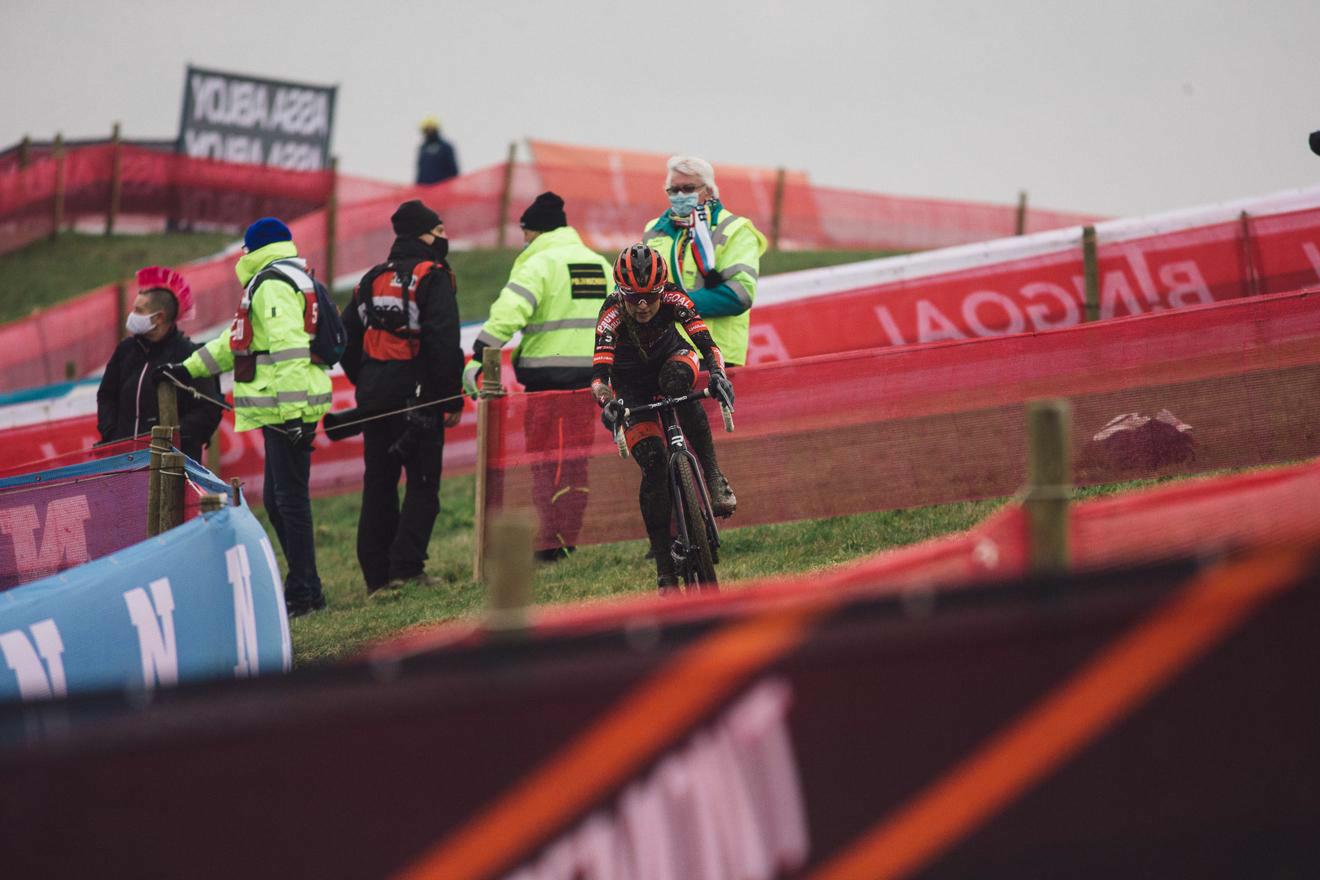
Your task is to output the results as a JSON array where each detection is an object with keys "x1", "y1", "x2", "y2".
[{"x1": 358, "y1": 414, "x2": 445, "y2": 590}]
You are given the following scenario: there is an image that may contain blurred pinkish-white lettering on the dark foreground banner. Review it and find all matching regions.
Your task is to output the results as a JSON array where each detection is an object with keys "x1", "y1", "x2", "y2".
[{"x1": 506, "y1": 679, "x2": 809, "y2": 880}]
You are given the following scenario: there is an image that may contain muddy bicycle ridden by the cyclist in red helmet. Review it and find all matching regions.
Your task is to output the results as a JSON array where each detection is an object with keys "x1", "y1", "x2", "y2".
[{"x1": 614, "y1": 388, "x2": 734, "y2": 592}]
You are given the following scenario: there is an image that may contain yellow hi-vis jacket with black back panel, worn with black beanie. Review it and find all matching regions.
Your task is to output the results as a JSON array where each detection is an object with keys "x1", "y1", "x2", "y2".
[{"x1": 477, "y1": 226, "x2": 614, "y2": 391}]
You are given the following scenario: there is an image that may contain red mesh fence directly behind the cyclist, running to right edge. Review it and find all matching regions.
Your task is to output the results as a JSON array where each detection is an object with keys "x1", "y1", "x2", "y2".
[{"x1": 487, "y1": 293, "x2": 1320, "y2": 546}]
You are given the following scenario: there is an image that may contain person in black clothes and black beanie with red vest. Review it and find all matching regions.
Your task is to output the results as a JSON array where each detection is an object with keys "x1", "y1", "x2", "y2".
[{"x1": 340, "y1": 199, "x2": 463, "y2": 596}]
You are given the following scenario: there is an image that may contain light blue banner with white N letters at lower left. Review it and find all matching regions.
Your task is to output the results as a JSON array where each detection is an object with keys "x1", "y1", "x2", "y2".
[{"x1": 0, "y1": 501, "x2": 292, "y2": 701}]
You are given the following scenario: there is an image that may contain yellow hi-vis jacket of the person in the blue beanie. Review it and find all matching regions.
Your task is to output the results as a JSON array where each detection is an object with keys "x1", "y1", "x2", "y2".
[{"x1": 183, "y1": 241, "x2": 330, "y2": 431}]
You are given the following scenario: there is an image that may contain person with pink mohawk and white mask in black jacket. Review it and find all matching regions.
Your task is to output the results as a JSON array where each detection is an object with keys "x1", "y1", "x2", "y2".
[{"x1": 96, "y1": 267, "x2": 223, "y2": 462}]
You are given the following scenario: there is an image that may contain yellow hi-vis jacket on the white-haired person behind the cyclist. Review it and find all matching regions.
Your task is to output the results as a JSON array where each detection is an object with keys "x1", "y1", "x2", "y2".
[{"x1": 642, "y1": 199, "x2": 766, "y2": 365}]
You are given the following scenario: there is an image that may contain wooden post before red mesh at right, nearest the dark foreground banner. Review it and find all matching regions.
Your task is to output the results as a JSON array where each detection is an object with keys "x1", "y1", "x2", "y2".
[{"x1": 1024, "y1": 398, "x2": 1072, "y2": 574}]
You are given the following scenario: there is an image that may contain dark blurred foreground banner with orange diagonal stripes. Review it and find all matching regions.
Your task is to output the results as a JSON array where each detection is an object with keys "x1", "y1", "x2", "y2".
[{"x1": 0, "y1": 550, "x2": 1320, "y2": 880}]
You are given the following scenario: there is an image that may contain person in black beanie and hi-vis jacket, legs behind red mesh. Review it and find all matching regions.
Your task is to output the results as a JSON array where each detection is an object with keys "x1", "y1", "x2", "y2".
[{"x1": 463, "y1": 193, "x2": 612, "y2": 562}]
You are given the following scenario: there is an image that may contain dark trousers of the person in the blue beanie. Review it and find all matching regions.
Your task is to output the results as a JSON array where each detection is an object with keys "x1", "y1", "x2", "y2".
[{"x1": 261, "y1": 427, "x2": 322, "y2": 606}]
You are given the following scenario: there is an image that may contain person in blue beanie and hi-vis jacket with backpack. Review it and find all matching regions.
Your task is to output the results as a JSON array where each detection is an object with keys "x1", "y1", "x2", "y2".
[{"x1": 156, "y1": 216, "x2": 330, "y2": 617}]
